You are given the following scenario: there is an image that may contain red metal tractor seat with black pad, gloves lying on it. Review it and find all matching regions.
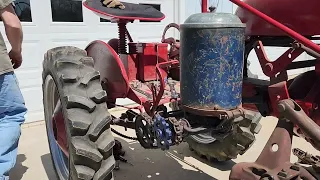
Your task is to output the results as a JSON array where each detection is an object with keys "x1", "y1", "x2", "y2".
[{"x1": 83, "y1": 0, "x2": 165, "y2": 21}]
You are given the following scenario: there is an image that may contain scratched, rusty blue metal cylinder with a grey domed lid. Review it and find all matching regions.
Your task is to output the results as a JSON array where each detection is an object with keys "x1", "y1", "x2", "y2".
[{"x1": 180, "y1": 13, "x2": 245, "y2": 115}]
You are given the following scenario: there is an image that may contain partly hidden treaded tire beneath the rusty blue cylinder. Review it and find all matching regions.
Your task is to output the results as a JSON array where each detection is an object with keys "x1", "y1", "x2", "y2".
[{"x1": 186, "y1": 112, "x2": 262, "y2": 161}]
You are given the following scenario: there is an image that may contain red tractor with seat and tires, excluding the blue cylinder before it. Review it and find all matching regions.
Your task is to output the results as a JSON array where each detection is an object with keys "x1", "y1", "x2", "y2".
[{"x1": 43, "y1": 0, "x2": 320, "y2": 180}]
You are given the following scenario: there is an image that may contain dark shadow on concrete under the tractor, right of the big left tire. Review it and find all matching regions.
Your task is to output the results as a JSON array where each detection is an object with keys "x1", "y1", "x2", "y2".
[{"x1": 114, "y1": 137, "x2": 215, "y2": 180}]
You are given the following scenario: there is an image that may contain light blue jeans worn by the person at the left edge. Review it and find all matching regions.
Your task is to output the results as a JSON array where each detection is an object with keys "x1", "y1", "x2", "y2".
[{"x1": 0, "y1": 72, "x2": 27, "y2": 180}]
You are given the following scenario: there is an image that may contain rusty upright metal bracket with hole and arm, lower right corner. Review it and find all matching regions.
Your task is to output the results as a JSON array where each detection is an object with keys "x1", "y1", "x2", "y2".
[{"x1": 229, "y1": 99, "x2": 320, "y2": 180}]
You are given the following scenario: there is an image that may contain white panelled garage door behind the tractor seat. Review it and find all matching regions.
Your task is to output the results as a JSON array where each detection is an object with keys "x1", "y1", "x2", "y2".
[{"x1": 1, "y1": 0, "x2": 179, "y2": 122}]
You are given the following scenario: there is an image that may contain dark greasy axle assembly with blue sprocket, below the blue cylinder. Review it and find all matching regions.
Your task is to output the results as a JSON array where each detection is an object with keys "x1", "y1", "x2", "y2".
[{"x1": 112, "y1": 106, "x2": 246, "y2": 150}]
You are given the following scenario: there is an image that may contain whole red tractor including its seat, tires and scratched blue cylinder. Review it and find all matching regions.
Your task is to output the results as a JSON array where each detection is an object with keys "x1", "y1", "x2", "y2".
[{"x1": 43, "y1": 0, "x2": 320, "y2": 180}]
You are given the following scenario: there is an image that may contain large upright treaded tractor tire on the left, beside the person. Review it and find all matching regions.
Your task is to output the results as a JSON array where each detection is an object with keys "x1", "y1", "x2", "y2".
[{"x1": 42, "y1": 46, "x2": 115, "y2": 180}]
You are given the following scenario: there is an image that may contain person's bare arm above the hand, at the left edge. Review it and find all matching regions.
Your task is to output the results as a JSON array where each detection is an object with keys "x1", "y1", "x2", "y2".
[{"x1": 0, "y1": 0, "x2": 23, "y2": 53}]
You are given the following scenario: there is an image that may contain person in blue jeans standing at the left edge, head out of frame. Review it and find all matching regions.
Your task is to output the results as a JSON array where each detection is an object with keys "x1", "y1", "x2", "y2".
[{"x1": 0, "y1": 0, "x2": 27, "y2": 180}]
